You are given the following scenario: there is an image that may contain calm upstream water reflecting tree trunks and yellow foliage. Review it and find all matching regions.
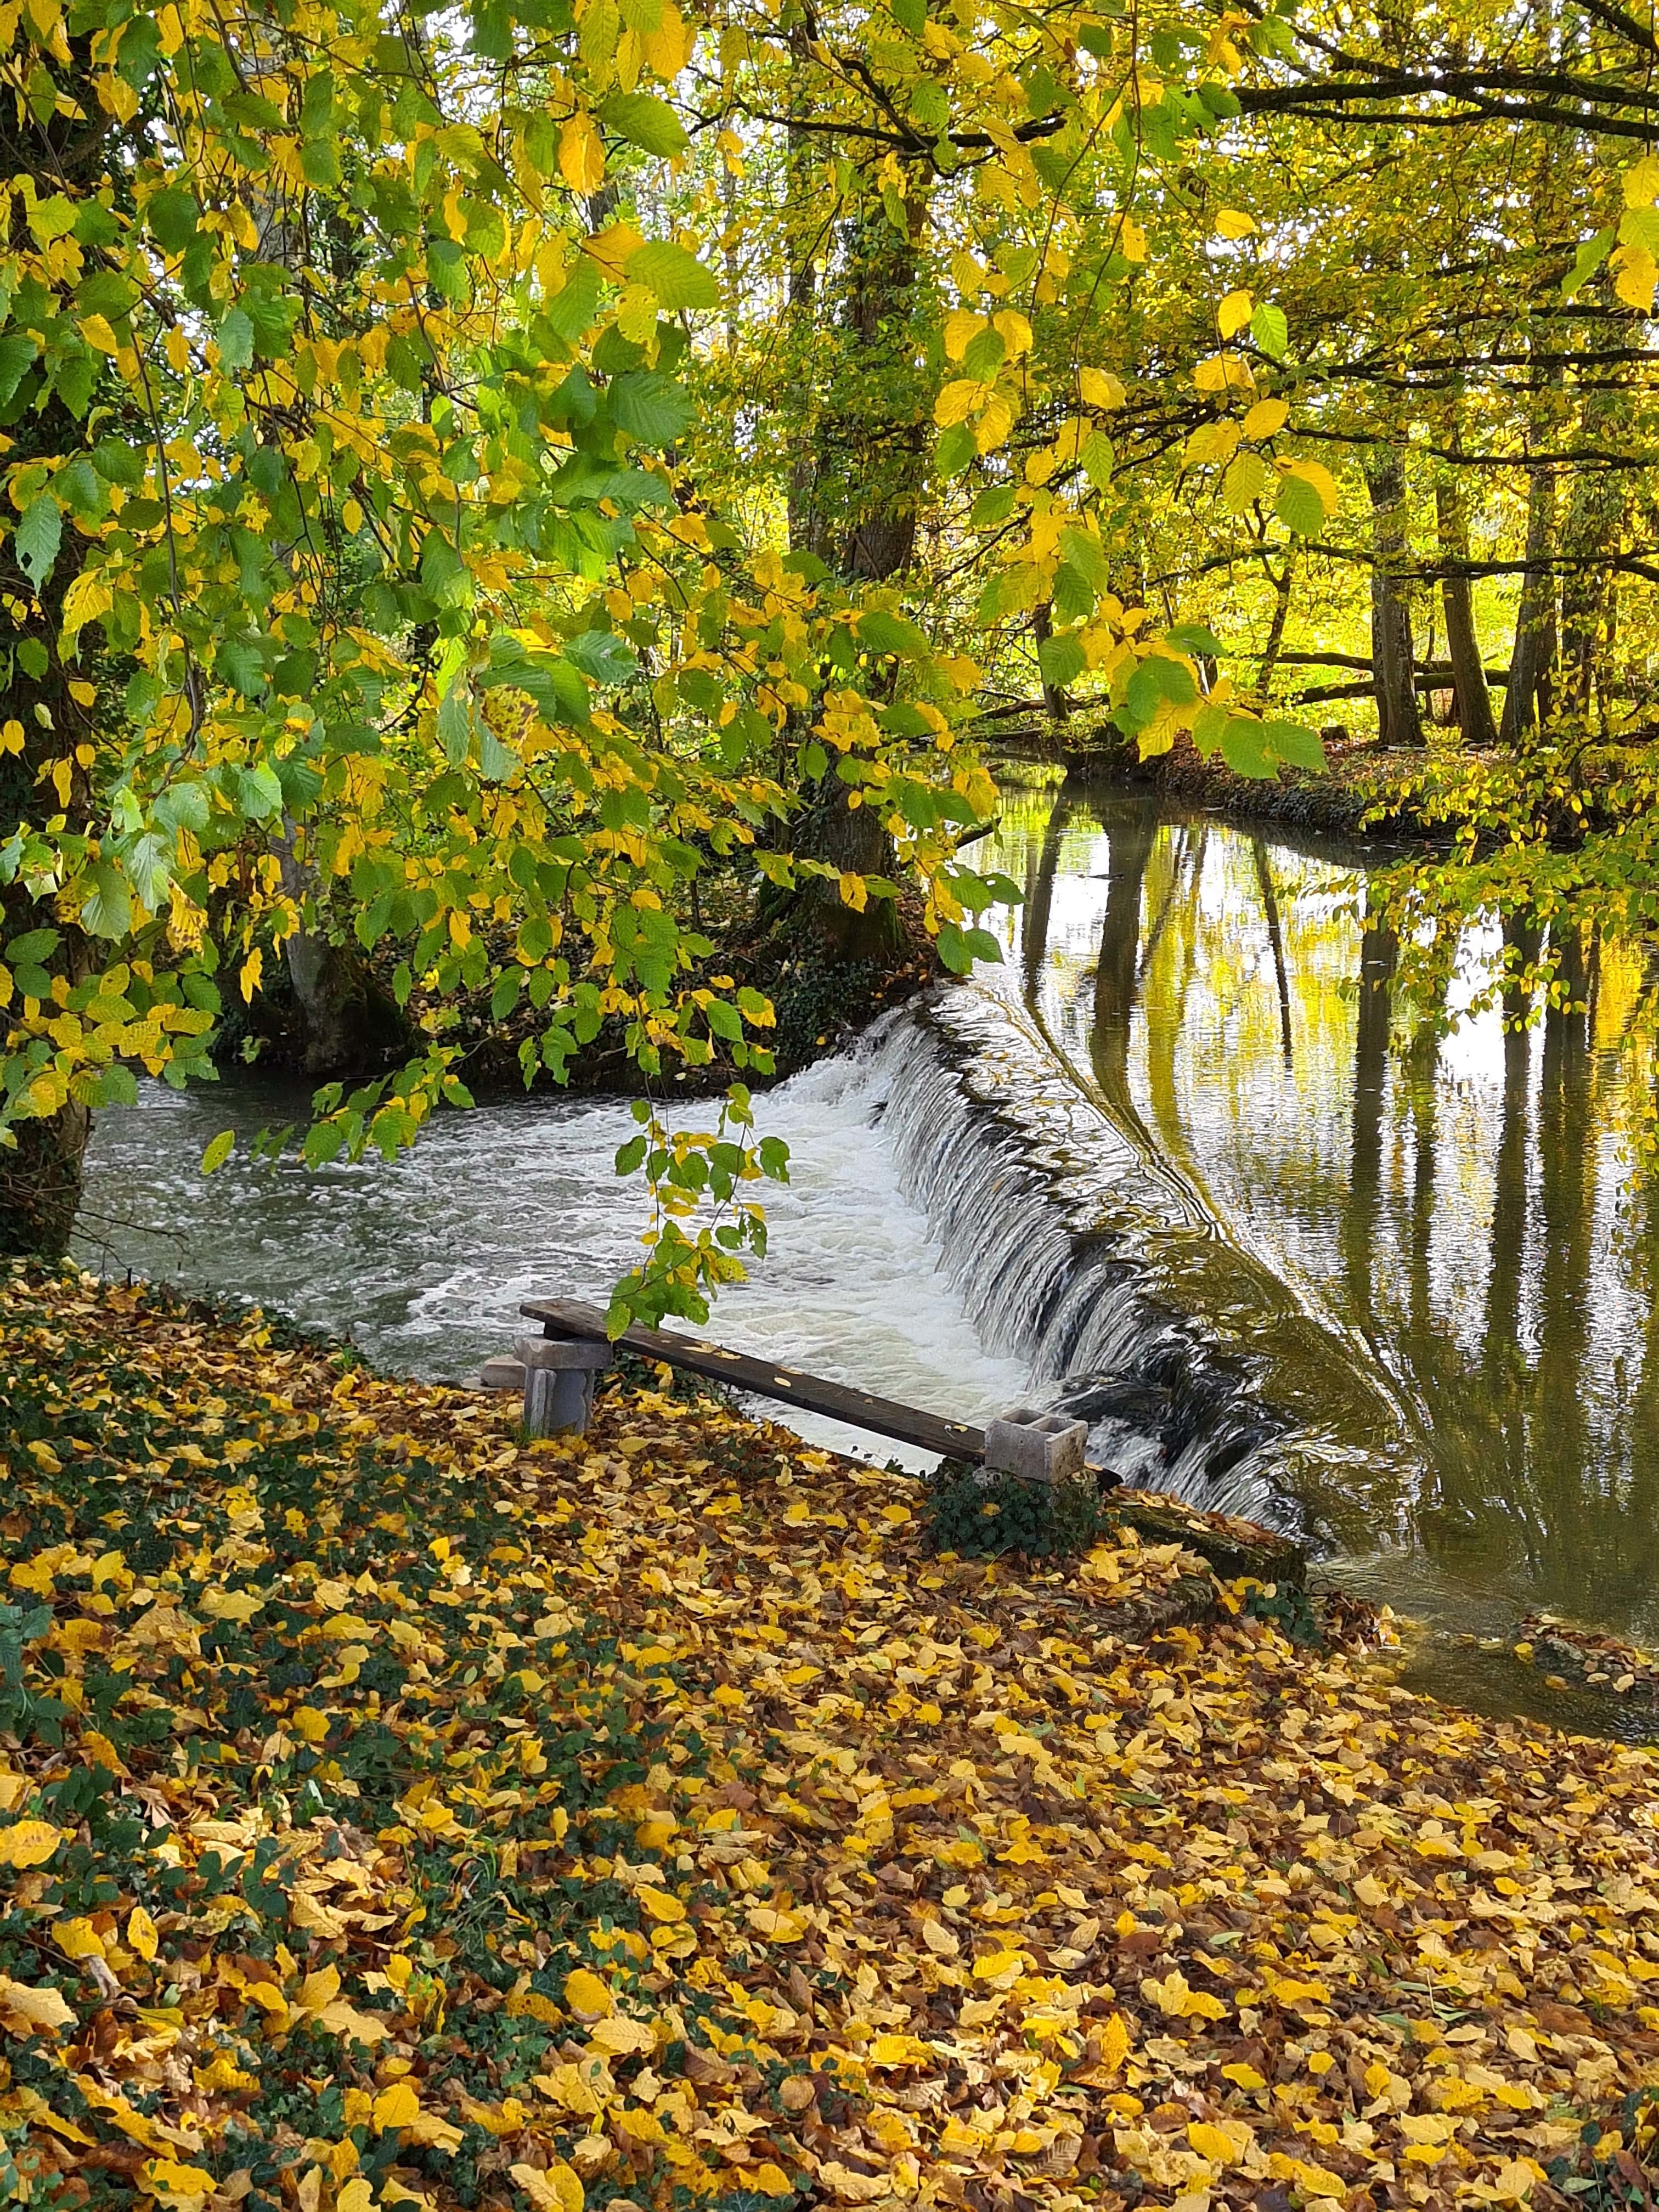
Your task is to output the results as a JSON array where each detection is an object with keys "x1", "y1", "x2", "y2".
[{"x1": 997, "y1": 781, "x2": 1659, "y2": 1639}]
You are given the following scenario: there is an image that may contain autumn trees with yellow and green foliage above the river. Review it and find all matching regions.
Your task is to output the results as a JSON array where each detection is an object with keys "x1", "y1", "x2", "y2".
[{"x1": 0, "y1": 0, "x2": 1659, "y2": 1316}]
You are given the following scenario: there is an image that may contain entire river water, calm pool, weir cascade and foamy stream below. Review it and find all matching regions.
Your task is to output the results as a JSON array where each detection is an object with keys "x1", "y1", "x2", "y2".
[{"x1": 75, "y1": 783, "x2": 1659, "y2": 1721}]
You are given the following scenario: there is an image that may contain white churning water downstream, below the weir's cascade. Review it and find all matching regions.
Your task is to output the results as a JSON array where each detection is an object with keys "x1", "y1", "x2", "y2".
[{"x1": 77, "y1": 1051, "x2": 1026, "y2": 1466}]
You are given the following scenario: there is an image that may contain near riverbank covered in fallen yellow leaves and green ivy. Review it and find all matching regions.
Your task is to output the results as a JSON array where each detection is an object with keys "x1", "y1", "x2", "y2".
[{"x1": 0, "y1": 1276, "x2": 1659, "y2": 2212}]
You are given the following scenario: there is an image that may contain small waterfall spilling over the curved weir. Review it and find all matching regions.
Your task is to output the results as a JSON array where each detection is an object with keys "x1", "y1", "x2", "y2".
[{"x1": 874, "y1": 984, "x2": 1415, "y2": 1542}]
